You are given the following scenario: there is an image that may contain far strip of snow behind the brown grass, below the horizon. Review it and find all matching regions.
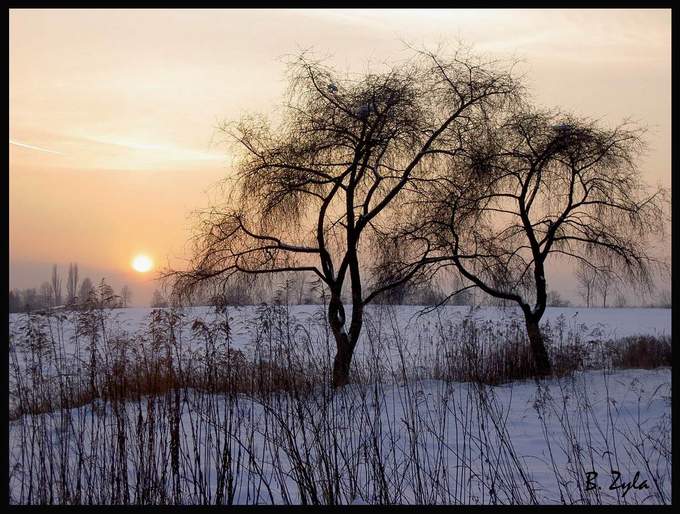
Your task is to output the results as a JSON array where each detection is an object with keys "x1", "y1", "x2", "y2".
[{"x1": 10, "y1": 305, "x2": 671, "y2": 364}]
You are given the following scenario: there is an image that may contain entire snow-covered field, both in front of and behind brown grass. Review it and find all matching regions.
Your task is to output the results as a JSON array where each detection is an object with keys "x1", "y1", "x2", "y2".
[{"x1": 9, "y1": 306, "x2": 672, "y2": 504}]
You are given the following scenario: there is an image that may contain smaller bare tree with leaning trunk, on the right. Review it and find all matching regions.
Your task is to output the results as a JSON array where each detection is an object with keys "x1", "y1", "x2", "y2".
[{"x1": 398, "y1": 107, "x2": 665, "y2": 375}]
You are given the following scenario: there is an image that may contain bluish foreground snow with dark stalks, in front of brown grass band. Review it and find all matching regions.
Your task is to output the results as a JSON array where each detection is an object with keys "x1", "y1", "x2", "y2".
[{"x1": 10, "y1": 369, "x2": 671, "y2": 504}]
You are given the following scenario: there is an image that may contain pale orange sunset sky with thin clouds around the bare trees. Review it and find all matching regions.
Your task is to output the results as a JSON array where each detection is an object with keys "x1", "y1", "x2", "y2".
[{"x1": 9, "y1": 9, "x2": 671, "y2": 305}]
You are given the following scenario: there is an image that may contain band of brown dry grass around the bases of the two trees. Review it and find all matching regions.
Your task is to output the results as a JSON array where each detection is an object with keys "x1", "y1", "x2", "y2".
[{"x1": 9, "y1": 306, "x2": 672, "y2": 420}]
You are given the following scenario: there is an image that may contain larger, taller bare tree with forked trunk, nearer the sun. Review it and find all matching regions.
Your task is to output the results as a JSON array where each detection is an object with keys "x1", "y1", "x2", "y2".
[{"x1": 166, "y1": 49, "x2": 517, "y2": 387}]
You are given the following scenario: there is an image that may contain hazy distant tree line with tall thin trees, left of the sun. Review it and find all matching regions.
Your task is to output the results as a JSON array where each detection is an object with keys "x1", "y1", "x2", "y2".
[{"x1": 9, "y1": 263, "x2": 132, "y2": 312}]
